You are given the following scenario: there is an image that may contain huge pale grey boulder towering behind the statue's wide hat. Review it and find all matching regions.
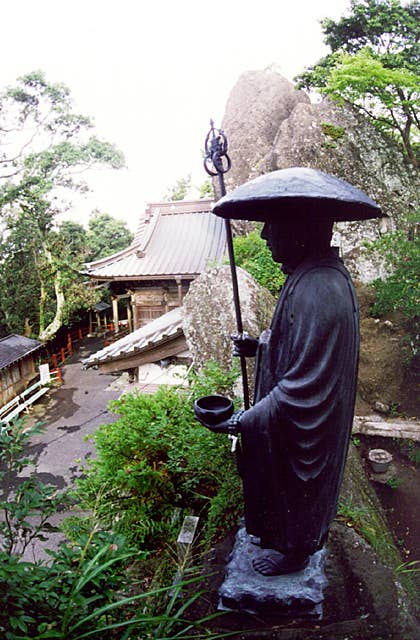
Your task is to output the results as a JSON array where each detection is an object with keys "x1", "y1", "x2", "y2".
[{"x1": 222, "y1": 71, "x2": 417, "y2": 282}]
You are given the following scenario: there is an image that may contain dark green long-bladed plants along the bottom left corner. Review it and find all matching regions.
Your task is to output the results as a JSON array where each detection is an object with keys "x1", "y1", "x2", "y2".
[{"x1": 0, "y1": 534, "x2": 230, "y2": 640}]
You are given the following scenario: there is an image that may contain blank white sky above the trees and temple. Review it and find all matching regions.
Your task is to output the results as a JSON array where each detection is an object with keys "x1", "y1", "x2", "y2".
[{"x1": 0, "y1": 0, "x2": 350, "y2": 230}]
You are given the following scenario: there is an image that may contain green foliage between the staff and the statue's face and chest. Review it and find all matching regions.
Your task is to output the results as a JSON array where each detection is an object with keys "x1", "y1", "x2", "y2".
[{"x1": 233, "y1": 227, "x2": 285, "y2": 295}]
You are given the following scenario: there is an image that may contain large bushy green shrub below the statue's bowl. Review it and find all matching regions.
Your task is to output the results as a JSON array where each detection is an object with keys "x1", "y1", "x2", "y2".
[{"x1": 71, "y1": 363, "x2": 241, "y2": 550}]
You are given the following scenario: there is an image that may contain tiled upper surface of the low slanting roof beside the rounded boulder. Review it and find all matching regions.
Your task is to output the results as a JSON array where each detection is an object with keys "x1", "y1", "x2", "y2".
[{"x1": 84, "y1": 307, "x2": 183, "y2": 368}]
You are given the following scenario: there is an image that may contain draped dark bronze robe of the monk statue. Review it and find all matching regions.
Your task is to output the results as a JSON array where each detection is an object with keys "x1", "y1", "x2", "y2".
[{"x1": 240, "y1": 249, "x2": 359, "y2": 555}]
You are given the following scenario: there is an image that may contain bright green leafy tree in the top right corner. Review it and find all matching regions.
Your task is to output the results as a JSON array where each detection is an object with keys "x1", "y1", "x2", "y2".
[{"x1": 297, "y1": 0, "x2": 420, "y2": 166}]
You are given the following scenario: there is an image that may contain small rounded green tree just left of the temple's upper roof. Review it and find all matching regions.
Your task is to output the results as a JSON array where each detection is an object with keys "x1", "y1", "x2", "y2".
[{"x1": 86, "y1": 209, "x2": 133, "y2": 261}]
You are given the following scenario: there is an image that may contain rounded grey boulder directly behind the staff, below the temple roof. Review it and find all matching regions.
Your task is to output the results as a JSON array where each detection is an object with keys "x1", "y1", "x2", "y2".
[{"x1": 183, "y1": 266, "x2": 275, "y2": 380}]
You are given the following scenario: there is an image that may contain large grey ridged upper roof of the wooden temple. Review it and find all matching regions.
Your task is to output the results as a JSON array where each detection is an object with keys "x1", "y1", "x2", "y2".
[{"x1": 86, "y1": 200, "x2": 226, "y2": 280}]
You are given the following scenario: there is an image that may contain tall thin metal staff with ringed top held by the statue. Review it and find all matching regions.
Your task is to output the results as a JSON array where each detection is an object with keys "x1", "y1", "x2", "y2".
[{"x1": 204, "y1": 120, "x2": 249, "y2": 409}]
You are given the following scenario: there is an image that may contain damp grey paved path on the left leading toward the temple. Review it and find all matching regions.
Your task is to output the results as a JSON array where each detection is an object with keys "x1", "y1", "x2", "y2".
[{"x1": 15, "y1": 338, "x2": 132, "y2": 560}]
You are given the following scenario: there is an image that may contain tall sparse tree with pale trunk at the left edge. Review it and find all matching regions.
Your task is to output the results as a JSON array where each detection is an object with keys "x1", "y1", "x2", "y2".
[{"x1": 0, "y1": 71, "x2": 123, "y2": 340}]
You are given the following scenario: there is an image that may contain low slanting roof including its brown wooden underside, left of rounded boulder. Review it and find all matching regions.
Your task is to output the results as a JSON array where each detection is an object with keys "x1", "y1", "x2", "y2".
[{"x1": 84, "y1": 307, "x2": 186, "y2": 371}]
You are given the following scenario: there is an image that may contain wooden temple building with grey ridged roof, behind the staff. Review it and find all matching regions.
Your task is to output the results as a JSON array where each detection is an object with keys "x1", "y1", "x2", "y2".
[{"x1": 85, "y1": 200, "x2": 226, "y2": 331}]
